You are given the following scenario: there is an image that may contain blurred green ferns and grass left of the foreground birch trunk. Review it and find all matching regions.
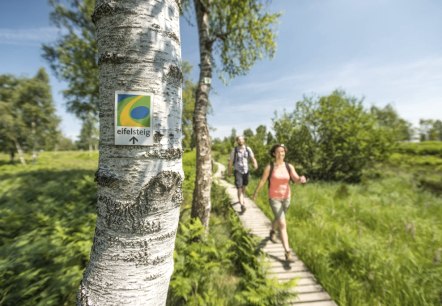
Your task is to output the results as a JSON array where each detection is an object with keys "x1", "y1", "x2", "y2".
[{"x1": 0, "y1": 152, "x2": 97, "y2": 305}]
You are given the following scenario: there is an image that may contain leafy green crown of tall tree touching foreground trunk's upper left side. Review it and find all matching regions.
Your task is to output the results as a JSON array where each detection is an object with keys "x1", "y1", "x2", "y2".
[{"x1": 43, "y1": 0, "x2": 99, "y2": 119}]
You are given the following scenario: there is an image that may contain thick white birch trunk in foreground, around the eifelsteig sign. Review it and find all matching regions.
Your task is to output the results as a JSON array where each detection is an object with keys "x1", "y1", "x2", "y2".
[{"x1": 77, "y1": 0, "x2": 183, "y2": 306}]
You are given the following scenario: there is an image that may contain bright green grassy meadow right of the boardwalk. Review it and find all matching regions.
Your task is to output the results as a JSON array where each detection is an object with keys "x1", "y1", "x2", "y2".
[{"x1": 242, "y1": 143, "x2": 442, "y2": 306}]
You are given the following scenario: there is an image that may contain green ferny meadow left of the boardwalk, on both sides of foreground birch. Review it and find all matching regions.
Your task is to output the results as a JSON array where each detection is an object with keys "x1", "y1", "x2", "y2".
[{"x1": 0, "y1": 152, "x2": 290, "y2": 306}]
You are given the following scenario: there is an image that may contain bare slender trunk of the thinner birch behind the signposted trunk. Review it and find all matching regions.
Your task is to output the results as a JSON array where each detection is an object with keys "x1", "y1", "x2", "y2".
[{"x1": 191, "y1": 0, "x2": 213, "y2": 229}]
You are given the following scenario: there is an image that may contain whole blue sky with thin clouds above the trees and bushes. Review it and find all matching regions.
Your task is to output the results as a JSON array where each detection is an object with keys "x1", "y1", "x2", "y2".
[{"x1": 0, "y1": 0, "x2": 442, "y2": 139}]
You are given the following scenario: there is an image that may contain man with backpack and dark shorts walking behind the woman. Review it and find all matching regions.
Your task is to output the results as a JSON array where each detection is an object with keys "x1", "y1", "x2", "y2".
[{"x1": 227, "y1": 136, "x2": 258, "y2": 213}]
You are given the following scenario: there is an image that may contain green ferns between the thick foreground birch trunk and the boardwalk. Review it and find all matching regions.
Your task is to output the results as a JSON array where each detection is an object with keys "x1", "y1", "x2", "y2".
[{"x1": 167, "y1": 152, "x2": 293, "y2": 306}]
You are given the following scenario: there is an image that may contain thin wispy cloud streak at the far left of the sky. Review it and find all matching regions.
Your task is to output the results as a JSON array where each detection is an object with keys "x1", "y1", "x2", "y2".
[{"x1": 0, "y1": 27, "x2": 58, "y2": 46}]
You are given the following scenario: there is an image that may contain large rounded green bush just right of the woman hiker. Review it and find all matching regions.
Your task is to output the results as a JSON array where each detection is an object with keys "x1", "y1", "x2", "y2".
[{"x1": 273, "y1": 91, "x2": 393, "y2": 182}]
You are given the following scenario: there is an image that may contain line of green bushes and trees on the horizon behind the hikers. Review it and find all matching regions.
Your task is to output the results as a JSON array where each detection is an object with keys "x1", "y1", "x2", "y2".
[{"x1": 213, "y1": 90, "x2": 442, "y2": 182}]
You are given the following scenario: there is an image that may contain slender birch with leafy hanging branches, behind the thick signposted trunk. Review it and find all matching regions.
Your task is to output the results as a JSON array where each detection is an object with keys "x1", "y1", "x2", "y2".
[{"x1": 186, "y1": 0, "x2": 279, "y2": 228}]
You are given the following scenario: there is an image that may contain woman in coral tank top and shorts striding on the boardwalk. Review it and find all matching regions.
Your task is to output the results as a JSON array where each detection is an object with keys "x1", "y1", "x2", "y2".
[{"x1": 253, "y1": 144, "x2": 307, "y2": 262}]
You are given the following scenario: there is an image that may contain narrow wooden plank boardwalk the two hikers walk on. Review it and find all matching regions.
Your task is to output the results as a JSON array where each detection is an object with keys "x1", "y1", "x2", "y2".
[{"x1": 215, "y1": 163, "x2": 336, "y2": 306}]
